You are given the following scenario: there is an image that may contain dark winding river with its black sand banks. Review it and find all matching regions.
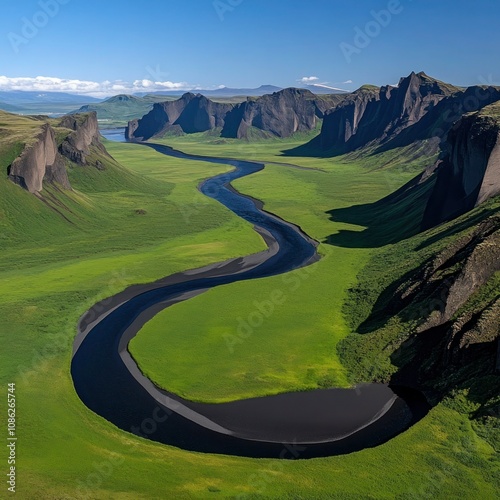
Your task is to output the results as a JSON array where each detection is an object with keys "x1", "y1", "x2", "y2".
[{"x1": 71, "y1": 131, "x2": 429, "y2": 459}]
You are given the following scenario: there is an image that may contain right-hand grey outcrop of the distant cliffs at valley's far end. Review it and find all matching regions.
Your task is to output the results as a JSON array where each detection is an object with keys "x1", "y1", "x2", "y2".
[{"x1": 221, "y1": 88, "x2": 344, "y2": 139}]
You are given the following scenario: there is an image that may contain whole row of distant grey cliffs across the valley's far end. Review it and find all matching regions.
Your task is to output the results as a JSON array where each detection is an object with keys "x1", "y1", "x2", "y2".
[{"x1": 125, "y1": 89, "x2": 345, "y2": 140}]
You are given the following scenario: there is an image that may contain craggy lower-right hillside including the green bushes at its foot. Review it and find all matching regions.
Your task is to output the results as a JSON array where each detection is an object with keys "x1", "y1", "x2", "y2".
[{"x1": 340, "y1": 209, "x2": 500, "y2": 412}]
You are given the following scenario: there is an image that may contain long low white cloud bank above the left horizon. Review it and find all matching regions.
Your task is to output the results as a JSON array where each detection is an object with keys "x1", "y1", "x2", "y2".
[{"x1": 0, "y1": 76, "x2": 193, "y2": 97}]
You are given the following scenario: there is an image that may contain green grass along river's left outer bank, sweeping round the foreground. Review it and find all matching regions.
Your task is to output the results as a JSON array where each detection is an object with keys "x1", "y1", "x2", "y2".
[{"x1": 0, "y1": 125, "x2": 498, "y2": 499}]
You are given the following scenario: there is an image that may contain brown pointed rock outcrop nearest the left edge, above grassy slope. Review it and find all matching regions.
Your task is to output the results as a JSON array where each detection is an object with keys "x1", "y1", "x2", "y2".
[{"x1": 8, "y1": 124, "x2": 71, "y2": 193}]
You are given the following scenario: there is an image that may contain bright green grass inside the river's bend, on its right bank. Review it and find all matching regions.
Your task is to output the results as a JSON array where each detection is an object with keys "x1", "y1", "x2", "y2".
[{"x1": 131, "y1": 147, "x2": 418, "y2": 402}]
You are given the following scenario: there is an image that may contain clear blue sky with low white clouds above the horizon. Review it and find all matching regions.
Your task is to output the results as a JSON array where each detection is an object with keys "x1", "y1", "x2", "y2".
[{"x1": 0, "y1": 0, "x2": 500, "y2": 95}]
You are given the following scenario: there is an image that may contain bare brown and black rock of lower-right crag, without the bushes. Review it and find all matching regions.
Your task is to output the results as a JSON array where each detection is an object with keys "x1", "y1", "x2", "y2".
[{"x1": 390, "y1": 214, "x2": 500, "y2": 392}]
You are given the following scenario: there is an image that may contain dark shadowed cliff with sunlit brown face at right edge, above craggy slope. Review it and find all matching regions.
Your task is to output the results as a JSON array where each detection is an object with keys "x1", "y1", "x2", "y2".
[{"x1": 422, "y1": 103, "x2": 500, "y2": 229}]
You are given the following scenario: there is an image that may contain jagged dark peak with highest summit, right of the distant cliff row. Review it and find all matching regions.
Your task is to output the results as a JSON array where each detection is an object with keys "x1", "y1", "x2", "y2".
[{"x1": 319, "y1": 73, "x2": 458, "y2": 153}]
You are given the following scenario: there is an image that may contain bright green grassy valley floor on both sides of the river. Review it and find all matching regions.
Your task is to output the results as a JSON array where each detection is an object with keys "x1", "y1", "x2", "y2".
[{"x1": 0, "y1": 138, "x2": 500, "y2": 500}]
